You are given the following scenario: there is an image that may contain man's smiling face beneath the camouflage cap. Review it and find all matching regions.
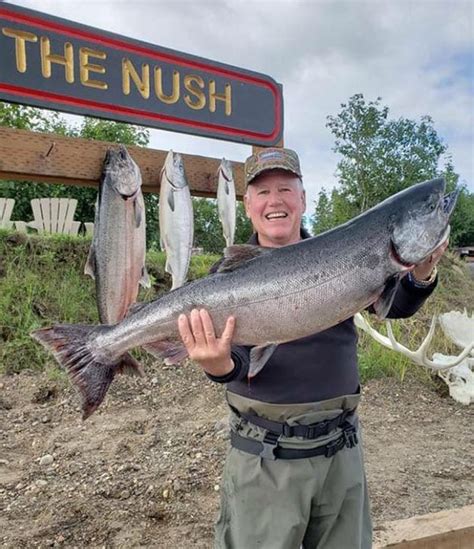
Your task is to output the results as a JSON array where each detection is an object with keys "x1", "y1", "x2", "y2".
[{"x1": 244, "y1": 170, "x2": 306, "y2": 248}]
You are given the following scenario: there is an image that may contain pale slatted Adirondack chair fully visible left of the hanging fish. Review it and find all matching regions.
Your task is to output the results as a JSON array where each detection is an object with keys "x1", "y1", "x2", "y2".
[{"x1": 15, "y1": 198, "x2": 81, "y2": 234}]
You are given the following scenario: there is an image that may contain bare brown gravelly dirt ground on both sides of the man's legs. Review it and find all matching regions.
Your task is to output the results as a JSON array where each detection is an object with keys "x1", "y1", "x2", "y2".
[{"x1": 0, "y1": 364, "x2": 474, "y2": 549}]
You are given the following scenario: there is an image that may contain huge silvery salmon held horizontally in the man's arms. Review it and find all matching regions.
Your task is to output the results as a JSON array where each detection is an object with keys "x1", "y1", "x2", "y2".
[{"x1": 33, "y1": 179, "x2": 457, "y2": 417}]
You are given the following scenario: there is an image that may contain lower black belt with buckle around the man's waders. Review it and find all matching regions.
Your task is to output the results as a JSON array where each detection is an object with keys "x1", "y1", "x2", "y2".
[{"x1": 230, "y1": 421, "x2": 358, "y2": 460}]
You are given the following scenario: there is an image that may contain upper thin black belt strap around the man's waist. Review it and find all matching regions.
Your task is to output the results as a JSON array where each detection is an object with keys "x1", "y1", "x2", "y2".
[{"x1": 230, "y1": 406, "x2": 355, "y2": 439}]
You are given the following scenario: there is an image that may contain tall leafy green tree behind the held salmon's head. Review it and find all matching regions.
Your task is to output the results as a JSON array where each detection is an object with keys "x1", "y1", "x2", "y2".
[{"x1": 312, "y1": 94, "x2": 474, "y2": 245}]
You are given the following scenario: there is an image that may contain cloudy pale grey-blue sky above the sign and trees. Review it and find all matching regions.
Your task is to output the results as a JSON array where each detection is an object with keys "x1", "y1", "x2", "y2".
[{"x1": 3, "y1": 0, "x2": 474, "y2": 215}]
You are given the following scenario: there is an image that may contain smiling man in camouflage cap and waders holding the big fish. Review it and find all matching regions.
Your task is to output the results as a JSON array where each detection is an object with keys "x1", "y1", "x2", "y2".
[{"x1": 178, "y1": 149, "x2": 446, "y2": 549}]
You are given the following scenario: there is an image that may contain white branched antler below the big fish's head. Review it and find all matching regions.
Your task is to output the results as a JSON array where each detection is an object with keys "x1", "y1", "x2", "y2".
[{"x1": 354, "y1": 313, "x2": 474, "y2": 370}]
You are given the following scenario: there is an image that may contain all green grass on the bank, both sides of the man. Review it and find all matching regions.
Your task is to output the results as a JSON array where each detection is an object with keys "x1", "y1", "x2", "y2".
[{"x1": 0, "y1": 230, "x2": 474, "y2": 381}]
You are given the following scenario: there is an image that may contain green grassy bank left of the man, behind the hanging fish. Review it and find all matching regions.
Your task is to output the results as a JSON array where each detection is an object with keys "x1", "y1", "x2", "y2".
[{"x1": 0, "y1": 230, "x2": 219, "y2": 375}]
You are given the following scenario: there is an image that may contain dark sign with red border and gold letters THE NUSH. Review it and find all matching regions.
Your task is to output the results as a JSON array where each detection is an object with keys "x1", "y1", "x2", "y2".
[{"x1": 0, "y1": 3, "x2": 283, "y2": 146}]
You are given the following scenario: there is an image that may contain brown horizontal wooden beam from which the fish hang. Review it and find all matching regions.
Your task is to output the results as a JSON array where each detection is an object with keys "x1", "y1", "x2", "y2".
[{"x1": 0, "y1": 127, "x2": 245, "y2": 199}]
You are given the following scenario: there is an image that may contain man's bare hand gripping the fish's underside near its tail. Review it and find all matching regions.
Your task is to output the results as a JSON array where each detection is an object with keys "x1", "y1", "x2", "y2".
[{"x1": 178, "y1": 309, "x2": 235, "y2": 377}]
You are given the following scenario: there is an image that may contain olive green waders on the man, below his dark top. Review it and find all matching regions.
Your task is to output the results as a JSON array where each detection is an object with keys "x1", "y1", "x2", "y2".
[{"x1": 215, "y1": 393, "x2": 372, "y2": 549}]
